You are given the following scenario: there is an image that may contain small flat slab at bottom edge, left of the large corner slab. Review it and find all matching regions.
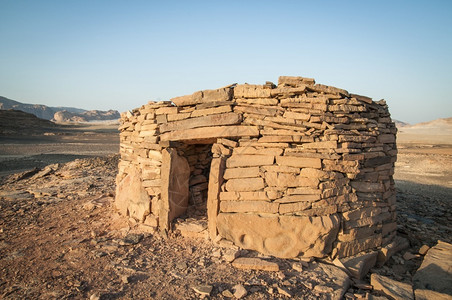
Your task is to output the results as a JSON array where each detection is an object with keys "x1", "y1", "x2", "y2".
[{"x1": 370, "y1": 273, "x2": 414, "y2": 300}]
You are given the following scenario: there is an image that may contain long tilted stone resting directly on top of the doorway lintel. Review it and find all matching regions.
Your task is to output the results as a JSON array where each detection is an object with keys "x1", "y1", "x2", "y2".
[{"x1": 160, "y1": 113, "x2": 242, "y2": 133}]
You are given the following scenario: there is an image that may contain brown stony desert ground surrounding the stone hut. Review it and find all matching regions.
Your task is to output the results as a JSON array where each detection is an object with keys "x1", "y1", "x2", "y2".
[{"x1": 0, "y1": 114, "x2": 452, "y2": 299}]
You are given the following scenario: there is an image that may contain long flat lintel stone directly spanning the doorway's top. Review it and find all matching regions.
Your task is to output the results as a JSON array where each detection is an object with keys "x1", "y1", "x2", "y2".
[{"x1": 160, "y1": 125, "x2": 259, "y2": 141}]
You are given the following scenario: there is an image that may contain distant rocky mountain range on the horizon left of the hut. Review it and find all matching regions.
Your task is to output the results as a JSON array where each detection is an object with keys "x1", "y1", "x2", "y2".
[{"x1": 0, "y1": 96, "x2": 120, "y2": 122}]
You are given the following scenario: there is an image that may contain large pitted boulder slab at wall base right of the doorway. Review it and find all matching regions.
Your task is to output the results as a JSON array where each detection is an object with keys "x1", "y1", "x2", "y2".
[{"x1": 217, "y1": 213, "x2": 339, "y2": 258}]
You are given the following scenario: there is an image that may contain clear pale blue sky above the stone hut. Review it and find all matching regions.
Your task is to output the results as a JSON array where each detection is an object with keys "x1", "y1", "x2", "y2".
[{"x1": 0, "y1": 0, "x2": 452, "y2": 123}]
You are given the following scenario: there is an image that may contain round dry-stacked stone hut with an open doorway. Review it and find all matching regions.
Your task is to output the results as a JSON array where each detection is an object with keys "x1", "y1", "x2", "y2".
[{"x1": 115, "y1": 76, "x2": 397, "y2": 258}]
